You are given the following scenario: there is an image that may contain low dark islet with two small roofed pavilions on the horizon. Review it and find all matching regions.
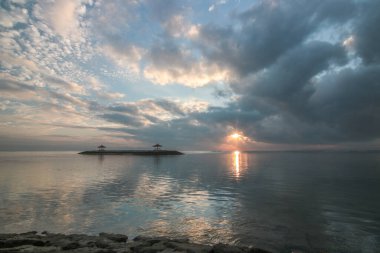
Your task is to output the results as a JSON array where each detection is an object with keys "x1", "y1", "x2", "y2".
[{"x1": 79, "y1": 143, "x2": 183, "y2": 156}]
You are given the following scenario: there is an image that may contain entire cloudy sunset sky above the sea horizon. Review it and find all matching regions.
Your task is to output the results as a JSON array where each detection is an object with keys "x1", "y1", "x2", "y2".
[{"x1": 0, "y1": 0, "x2": 380, "y2": 150}]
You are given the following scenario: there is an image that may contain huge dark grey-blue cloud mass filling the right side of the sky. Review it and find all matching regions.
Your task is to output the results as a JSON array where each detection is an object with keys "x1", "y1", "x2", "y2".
[{"x1": 128, "y1": 1, "x2": 380, "y2": 148}]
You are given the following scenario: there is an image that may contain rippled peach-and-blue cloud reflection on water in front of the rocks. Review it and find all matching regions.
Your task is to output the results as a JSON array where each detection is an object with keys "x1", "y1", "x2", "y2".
[{"x1": 133, "y1": 170, "x2": 233, "y2": 243}]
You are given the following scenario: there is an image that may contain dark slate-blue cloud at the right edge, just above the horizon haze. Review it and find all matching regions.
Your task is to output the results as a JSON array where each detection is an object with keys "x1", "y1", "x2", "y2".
[{"x1": 310, "y1": 65, "x2": 380, "y2": 141}]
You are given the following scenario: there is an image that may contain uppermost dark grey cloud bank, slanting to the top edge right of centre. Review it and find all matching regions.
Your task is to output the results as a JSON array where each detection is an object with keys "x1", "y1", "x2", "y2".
[{"x1": 200, "y1": 0, "x2": 355, "y2": 75}]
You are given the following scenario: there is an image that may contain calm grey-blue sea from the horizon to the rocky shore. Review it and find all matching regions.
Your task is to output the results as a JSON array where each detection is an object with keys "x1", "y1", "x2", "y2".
[{"x1": 0, "y1": 152, "x2": 380, "y2": 252}]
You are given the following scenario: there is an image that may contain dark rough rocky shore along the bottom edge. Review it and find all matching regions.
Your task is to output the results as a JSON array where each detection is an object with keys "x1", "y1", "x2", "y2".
[{"x1": 0, "y1": 231, "x2": 269, "y2": 253}]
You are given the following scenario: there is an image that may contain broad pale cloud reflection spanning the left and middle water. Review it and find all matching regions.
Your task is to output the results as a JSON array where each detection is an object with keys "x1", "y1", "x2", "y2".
[{"x1": 0, "y1": 152, "x2": 243, "y2": 242}]
